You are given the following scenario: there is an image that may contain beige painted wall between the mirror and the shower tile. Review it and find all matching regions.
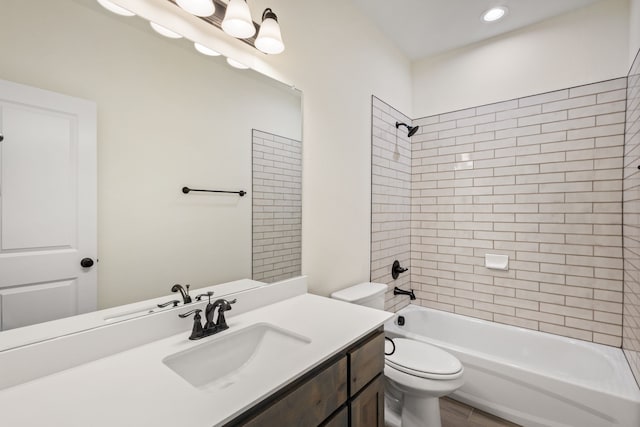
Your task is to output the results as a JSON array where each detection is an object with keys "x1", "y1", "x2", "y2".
[{"x1": 79, "y1": 0, "x2": 411, "y2": 295}]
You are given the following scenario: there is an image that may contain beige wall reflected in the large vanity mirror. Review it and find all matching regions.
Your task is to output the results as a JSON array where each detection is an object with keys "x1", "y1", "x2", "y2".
[{"x1": 0, "y1": 0, "x2": 302, "y2": 334}]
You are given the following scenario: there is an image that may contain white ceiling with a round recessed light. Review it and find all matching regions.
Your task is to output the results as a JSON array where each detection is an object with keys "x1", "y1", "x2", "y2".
[{"x1": 353, "y1": 0, "x2": 598, "y2": 60}]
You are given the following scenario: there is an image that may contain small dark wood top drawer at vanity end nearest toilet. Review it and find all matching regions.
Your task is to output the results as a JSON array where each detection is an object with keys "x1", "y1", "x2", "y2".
[{"x1": 348, "y1": 332, "x2": 384, "y2": 396}]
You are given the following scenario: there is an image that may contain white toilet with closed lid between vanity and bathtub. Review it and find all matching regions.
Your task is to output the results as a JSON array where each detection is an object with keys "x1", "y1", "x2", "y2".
[{"x1": 331, "y1": 283, "x2": 464, "y2": 427}]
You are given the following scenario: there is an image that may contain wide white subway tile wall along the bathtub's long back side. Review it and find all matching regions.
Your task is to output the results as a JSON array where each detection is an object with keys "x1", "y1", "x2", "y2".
[{"x1": 410, "y1": 78, "x2": 624, "y2": 348}]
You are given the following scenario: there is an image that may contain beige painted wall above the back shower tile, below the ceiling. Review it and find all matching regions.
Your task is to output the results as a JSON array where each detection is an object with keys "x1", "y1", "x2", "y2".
[{"x1": 413, "y1": 0, "x2": 638, "y2": 117}]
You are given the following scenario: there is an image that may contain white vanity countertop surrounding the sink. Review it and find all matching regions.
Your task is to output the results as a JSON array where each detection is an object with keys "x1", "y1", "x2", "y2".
[{"x1": 0, "y1": 294, "x2": 392, "y2": 427}]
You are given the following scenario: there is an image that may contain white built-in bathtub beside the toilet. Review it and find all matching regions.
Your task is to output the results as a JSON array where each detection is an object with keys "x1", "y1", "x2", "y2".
[{"x1": 385, "y1": 305, "x2": 640, "y2": 427}]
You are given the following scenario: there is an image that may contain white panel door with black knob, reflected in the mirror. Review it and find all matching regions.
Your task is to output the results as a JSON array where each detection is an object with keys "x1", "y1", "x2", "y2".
[{"x1": 0, "y1": 80, "x2": 97, "y2": 330}]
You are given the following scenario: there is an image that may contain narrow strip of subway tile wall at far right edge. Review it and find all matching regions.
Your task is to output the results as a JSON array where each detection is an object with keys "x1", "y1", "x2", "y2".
[{"x1": 622, "y1": 51, "x2": 640, "y2": 384}]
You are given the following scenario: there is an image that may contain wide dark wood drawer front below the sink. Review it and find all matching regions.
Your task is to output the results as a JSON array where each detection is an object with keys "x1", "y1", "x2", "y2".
[{"x1": 242, "y1": 357, "x2": 347, "y2": 427}]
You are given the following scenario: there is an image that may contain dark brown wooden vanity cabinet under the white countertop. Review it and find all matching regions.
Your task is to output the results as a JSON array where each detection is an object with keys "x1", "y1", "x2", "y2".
[{"x1": 226, "y1": 329, "x2": 384, "y2": 427}]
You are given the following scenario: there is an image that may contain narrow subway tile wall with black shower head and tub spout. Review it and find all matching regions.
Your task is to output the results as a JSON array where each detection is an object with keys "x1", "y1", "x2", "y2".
[{"x1": 371, "y1": 96, "x2": 411, "y2": 312}]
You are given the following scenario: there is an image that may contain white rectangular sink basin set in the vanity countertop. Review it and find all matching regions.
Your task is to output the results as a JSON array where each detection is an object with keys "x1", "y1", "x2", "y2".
[{"x1": 162, "y1": 323, "x2": 311, "y2": 390}]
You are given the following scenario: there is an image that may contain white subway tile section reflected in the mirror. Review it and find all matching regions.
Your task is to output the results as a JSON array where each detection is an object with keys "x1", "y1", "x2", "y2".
[{"x1": 252, "y1": 130, "x2": 302, "y2": 283}]
